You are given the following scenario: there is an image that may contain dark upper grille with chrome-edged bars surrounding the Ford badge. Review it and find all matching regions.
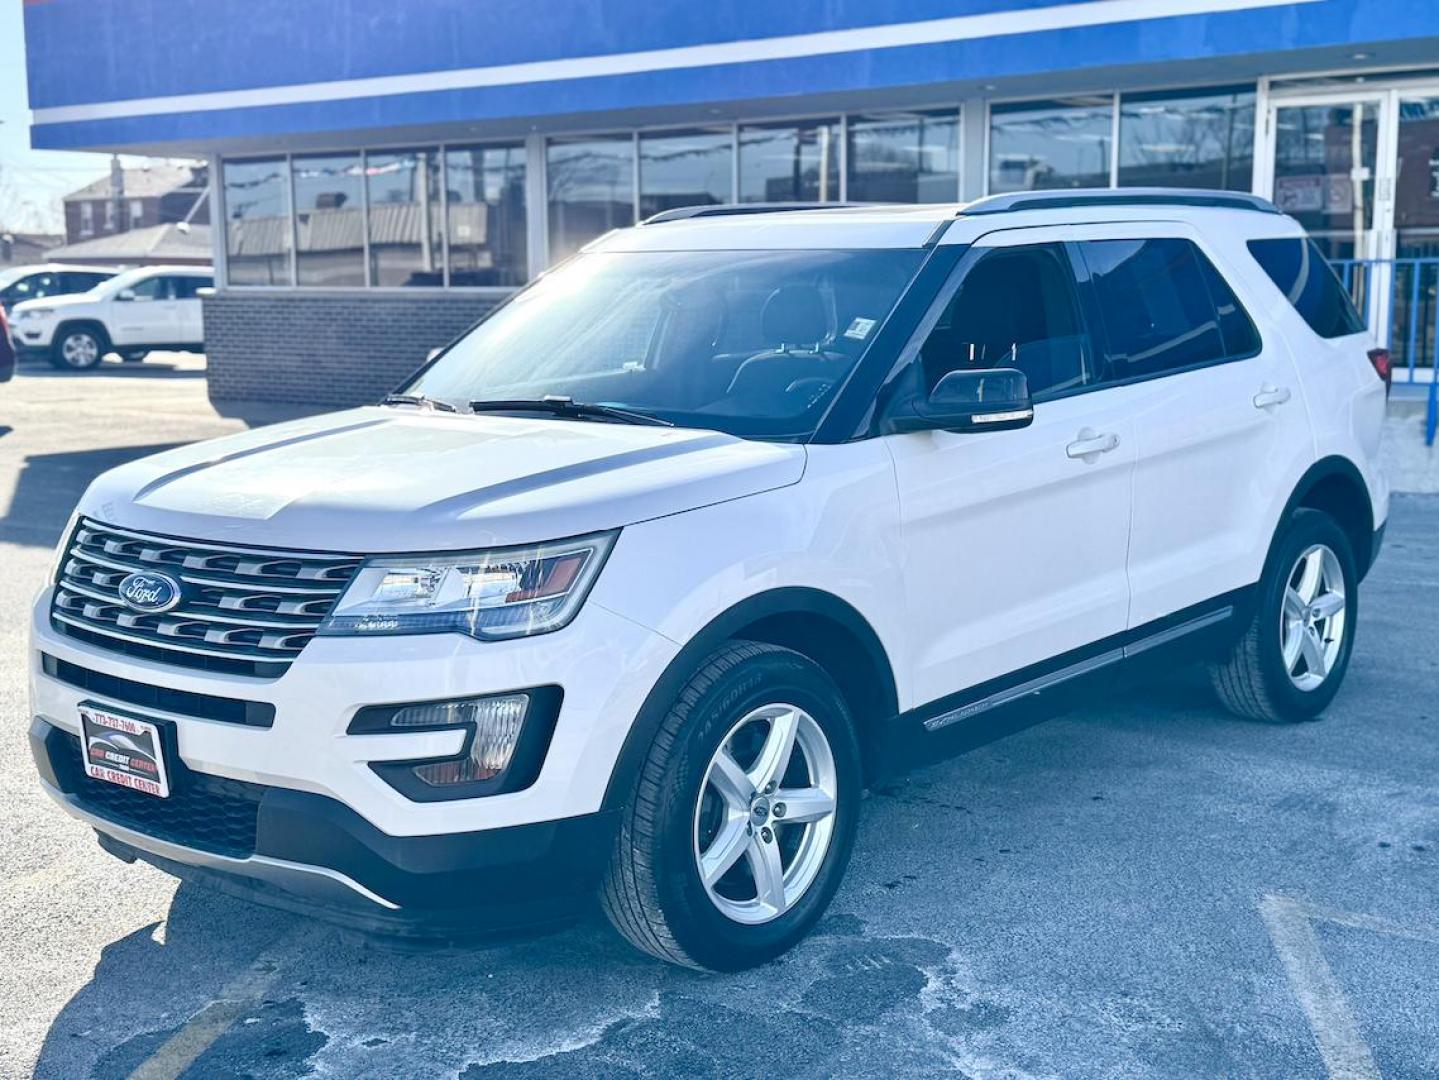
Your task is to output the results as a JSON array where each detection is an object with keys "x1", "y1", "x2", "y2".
[{"x1": 50, "y1": 519, "x2": 361, "y2": 677}]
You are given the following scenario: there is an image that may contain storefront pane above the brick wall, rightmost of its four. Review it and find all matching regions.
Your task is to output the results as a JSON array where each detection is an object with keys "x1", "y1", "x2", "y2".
[{"x1": 445, "y1": 145, "x2": 530, "y2": 288}]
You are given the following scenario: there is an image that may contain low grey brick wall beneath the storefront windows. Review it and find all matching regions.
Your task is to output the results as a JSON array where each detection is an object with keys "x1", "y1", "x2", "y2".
[{"x1": 204, "y1": 290, "x2": 498, "y2": 407}]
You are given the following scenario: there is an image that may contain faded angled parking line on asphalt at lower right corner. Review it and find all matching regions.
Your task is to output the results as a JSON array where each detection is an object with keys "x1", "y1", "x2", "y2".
[{"x1": 1259, "y1": 896, "x2": 1439, "y2": 1080}]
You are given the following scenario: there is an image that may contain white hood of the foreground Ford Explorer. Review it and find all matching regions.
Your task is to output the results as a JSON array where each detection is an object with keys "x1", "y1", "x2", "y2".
[{"x1": 81, "y1": 407, "x2": 806, "y2": 554}]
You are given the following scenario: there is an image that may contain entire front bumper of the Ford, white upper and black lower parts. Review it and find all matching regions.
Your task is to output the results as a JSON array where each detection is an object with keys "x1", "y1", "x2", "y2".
[{"x1": 30, "y1": 598, "x2": 675, "y2": 939}]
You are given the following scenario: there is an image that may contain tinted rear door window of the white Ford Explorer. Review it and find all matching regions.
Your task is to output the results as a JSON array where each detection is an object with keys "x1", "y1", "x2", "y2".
[{"x1": 1079, "y1": 239, "x2": 1248, "y2": 380}]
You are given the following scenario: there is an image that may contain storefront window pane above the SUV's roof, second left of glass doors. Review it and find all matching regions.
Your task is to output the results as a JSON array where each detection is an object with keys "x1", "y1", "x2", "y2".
[{"x1": 989, "y1": 95, "x2": 1114, "y2": 194}]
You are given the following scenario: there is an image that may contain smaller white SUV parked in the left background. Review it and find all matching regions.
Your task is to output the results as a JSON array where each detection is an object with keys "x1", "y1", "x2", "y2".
[{"x1": 10, "y1": 266, "x2": 214, "y2": 371}]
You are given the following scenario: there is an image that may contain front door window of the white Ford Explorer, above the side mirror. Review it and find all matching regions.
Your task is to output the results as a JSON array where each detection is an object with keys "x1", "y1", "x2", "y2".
[{"x1": 920, "y1": 244, "x2": 1094, "y2": 397}]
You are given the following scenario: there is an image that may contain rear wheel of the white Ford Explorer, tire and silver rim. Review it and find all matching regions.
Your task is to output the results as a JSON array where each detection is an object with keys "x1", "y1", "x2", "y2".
[{"x1": 1209, "y1": 509, "x2": 1358, "y2": 722}]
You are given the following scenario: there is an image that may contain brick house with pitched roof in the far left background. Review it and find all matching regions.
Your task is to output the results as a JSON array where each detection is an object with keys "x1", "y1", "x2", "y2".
[{"x1": 63, "y1": 163, "x2": 210, "y2": 244}]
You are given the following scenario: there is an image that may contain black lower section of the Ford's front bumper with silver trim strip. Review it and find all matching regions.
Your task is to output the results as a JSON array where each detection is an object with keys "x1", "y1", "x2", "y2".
[{"x1": 30, "y1": 719, "x2": 616, "y2": 939}]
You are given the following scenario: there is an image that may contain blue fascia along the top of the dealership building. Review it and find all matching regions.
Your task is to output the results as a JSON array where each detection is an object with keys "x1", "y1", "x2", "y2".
[{"x1": 24, "y1": 0, "x2": 1439, "y2": 148}]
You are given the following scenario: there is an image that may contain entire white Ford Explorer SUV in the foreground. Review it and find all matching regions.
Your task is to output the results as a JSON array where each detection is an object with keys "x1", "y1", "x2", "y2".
[{"x1": 30, "y1": 191, "x2": 1389, "y2": 969}]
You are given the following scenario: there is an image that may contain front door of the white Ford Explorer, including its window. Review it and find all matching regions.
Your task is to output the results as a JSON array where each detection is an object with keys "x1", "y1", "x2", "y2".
[{"x1": 885, "y1": 230, "x2": 1135, "y2": 702}]
